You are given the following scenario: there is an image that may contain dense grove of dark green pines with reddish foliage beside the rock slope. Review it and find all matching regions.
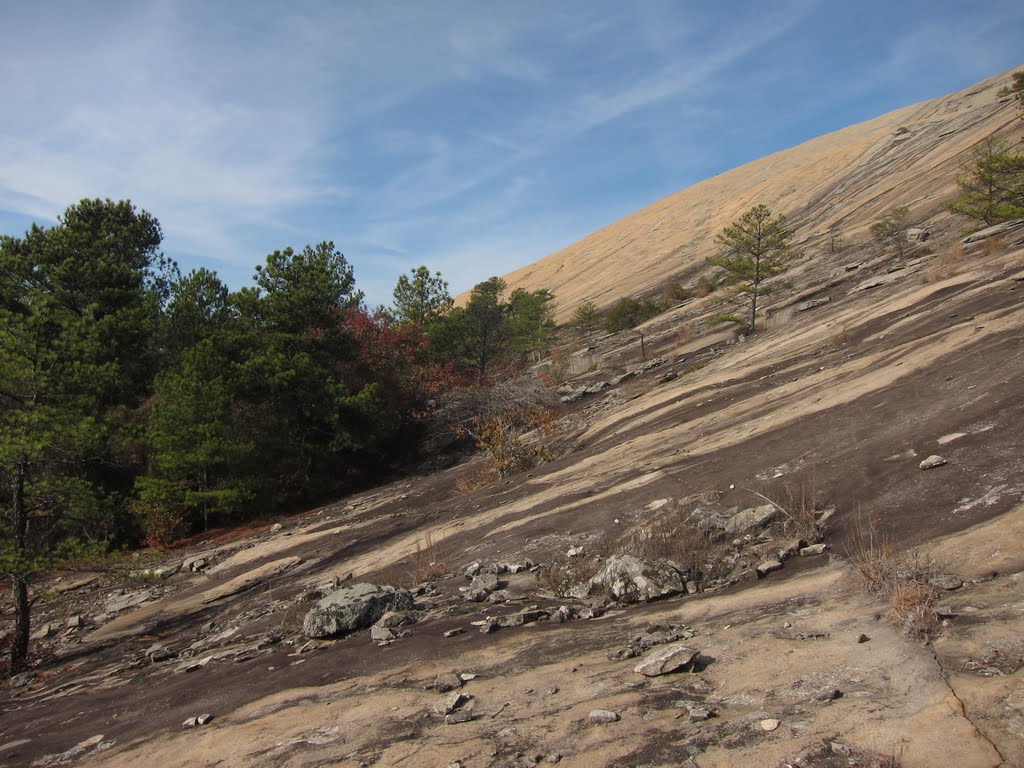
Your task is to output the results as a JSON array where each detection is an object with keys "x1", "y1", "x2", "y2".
[{"x1": 0, "y1": 200, "x2": 554, "y2": 667}]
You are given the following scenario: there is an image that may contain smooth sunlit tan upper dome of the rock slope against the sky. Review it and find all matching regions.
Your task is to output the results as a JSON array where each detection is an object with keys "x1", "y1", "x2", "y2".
[{"x1": 491, "y1": 63, "x2": 1019, "y2": 322}]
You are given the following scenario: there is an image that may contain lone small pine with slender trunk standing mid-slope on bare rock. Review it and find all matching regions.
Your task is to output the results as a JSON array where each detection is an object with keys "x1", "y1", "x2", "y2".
[{"x1": 708, "y1": 205, "x2": 794, "y2": 333}]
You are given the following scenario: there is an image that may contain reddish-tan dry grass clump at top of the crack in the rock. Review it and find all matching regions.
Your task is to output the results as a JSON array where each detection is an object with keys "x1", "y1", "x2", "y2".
[{"x1": 849, "y1": 517, "x2": 939, "y2": 638}]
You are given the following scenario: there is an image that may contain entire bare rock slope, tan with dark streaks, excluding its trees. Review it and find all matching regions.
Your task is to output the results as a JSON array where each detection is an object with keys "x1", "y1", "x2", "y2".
[{"x1": 6, "y1": 67, "x2": 1024, "y2": 768}]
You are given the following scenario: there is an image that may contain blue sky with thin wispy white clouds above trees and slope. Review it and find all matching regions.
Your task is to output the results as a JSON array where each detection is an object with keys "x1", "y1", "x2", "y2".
[{"x1": 0, "y1": 0, "x2": 1024, "y2": 306}]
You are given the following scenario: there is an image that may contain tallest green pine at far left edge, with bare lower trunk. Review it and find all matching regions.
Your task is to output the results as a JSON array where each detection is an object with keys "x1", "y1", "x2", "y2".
[{"x1": 0, "y1": 200, "x2": 168, "y2": 670}]
